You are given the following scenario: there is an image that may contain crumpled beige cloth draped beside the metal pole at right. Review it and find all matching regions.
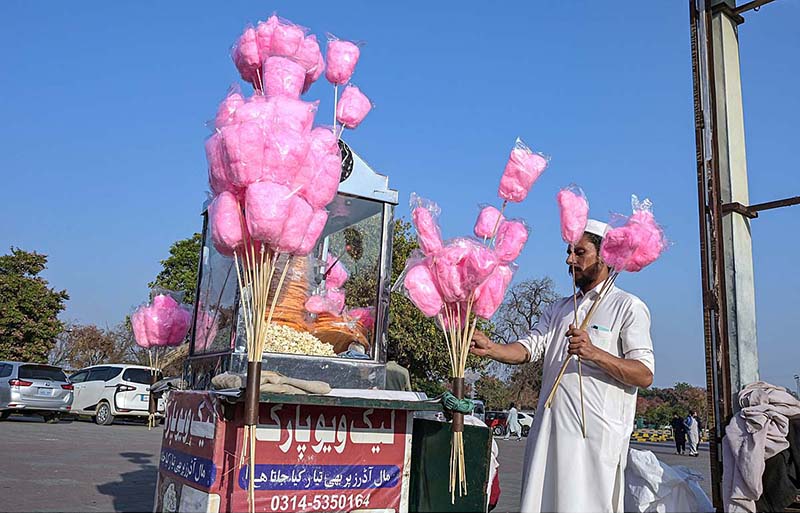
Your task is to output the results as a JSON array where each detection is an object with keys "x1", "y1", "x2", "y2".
[{"x1": 722, "y1": 381, "x2": 800, "y2": 512}]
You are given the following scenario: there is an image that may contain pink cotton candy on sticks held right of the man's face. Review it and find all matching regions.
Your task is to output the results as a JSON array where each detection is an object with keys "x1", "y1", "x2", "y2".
[{"x1": 545, "y1": 195, "x2": 669, "y2": 408}]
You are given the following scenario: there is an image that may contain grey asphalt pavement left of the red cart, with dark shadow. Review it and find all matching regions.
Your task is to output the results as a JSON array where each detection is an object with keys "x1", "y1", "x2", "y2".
[{"x1": 0, "y1": 416, "x2": 162, "y2": 512}]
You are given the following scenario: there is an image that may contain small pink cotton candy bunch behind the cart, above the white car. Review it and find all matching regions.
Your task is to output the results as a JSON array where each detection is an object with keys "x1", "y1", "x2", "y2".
[{"x1": 131, "y1": 290, "x2": 192, "y2": 428}]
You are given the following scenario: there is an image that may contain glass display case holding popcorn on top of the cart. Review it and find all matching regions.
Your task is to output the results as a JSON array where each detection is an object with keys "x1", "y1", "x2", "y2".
[{"x1": 185, "y1": 142, "x2": 397, "y2": 388}]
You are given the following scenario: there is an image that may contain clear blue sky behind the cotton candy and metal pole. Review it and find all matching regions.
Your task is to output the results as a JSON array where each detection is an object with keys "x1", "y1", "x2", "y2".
[{"x1": 0, "y1": 1, "x2": 800, "y2": 386}]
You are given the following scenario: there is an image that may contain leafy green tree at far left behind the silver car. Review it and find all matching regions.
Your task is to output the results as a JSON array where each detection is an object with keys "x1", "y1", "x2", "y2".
[{"x1": 0, "y1": 247, "x2": 69, "y2": 363}]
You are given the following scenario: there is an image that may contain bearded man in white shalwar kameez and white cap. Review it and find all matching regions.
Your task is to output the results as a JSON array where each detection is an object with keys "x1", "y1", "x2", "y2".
[{"x1": 471, "y1": 220, "x2": 655, "y2": 513}]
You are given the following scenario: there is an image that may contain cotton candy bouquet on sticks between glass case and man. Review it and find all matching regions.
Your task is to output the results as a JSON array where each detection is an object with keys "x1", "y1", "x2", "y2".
[{"x1": 394, "y1": 139, "x2": 547, "y2": 503}]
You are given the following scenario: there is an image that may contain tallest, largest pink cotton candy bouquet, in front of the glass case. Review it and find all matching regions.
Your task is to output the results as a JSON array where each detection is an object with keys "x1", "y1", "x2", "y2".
[{"x1": 214, "y1": 15, "x2": 372, "y2": 511}]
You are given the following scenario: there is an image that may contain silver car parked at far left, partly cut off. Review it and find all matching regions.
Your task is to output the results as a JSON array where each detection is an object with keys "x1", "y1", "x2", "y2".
[{"x1": 0, "y1": 362, "x2": 73, "y2": 422}]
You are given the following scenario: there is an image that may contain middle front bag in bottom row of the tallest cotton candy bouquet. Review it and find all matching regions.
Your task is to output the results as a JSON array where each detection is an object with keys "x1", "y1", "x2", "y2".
[{"x1": 245, "y1": 182, "x2": 292, "y2": 246}]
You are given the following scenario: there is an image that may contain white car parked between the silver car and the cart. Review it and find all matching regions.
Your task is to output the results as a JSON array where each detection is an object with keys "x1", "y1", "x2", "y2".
[{"x1": 69, "y1": 364, "x2": 164, "y2": 426}]
